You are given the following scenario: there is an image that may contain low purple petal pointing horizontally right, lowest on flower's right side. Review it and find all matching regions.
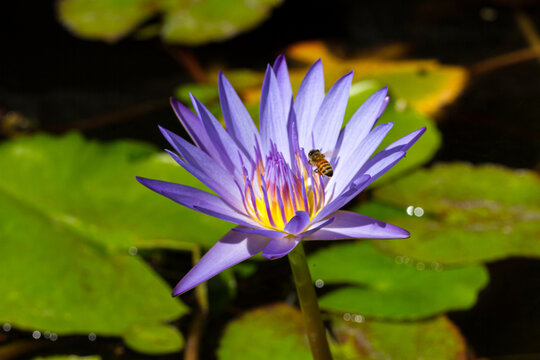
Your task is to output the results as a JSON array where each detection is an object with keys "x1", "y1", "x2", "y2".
[{"x1": 303, "y1": 211, "x2": 409, "y2": 240}]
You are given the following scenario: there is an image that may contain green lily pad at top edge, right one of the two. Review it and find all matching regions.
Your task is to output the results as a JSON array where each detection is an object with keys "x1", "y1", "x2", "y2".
[{"x1": 161, "y1": 0, "x2": 282, "y2": 45}]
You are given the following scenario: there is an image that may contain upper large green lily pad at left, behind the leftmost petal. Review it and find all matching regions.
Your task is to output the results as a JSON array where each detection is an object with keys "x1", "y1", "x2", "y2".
[{"x1": 0, "y1": 130, "x2": 232, "y2": 252}]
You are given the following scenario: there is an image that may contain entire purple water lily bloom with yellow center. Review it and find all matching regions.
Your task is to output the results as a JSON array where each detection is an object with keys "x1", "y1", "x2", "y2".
[{"x1": 138, "y1": 56, "x2": 425, "y2": 296}]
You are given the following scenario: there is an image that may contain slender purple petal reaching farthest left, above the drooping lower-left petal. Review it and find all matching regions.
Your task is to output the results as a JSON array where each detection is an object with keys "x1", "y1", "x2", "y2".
[{"x1": 137, "y1": 176, "x2": 255, "y2": 226}]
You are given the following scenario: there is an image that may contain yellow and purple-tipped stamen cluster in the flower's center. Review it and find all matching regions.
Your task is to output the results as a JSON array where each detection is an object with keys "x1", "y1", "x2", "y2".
[{"x1": 239, "y1": 142, "x2": 324, "y2": 231}]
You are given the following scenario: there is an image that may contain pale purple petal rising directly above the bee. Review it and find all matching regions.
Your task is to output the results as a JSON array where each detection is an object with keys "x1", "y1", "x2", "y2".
[{"x1": 312, "y1": 72, "x2": 353, "y2": 152}]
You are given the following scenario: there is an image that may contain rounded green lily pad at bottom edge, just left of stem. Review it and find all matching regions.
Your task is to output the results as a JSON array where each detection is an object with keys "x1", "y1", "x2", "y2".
[{"x1": 217, "y1": 304, "x2": 311, "y2": 360}]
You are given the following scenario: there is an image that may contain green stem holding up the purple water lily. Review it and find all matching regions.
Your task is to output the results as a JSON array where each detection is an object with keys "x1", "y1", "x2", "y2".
[{"x1": 289, "y1": 242, "x2": 332, "y2": 360}]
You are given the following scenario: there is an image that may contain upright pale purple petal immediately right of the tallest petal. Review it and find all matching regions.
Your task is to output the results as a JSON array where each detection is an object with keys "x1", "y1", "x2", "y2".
[{"x1": 293, "y1": 60, "x2": 324, "y2": 151}]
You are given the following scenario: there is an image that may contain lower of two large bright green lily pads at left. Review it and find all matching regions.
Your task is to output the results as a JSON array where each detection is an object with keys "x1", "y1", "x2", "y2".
[{"x1": 0, "y1": 187, "x2": 187, "y2": 352}]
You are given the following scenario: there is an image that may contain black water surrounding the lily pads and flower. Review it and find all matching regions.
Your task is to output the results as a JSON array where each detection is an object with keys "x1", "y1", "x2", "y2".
[{"x1": 0, "y1": 0, "x2": 540, "y2": 359}]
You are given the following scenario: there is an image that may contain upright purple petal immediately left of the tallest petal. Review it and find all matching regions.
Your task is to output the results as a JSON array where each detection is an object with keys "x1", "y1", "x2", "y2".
[{"x1": 260, "y1": 66, "x2": 291, "y2": 164}]
